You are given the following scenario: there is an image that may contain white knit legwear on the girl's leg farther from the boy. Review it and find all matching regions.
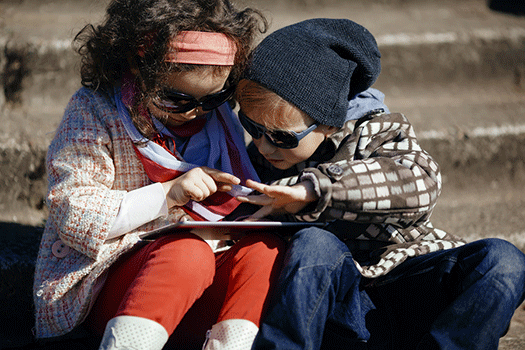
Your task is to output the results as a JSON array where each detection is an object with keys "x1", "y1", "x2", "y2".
[{"x1": 98, "y1": 316, "x2": 169, "y2": 350}]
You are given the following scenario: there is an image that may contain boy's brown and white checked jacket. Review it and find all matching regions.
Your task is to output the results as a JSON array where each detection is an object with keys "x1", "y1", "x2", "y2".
[{"x1": 249, "y1": 110, "x2": 464, "y2": 278}]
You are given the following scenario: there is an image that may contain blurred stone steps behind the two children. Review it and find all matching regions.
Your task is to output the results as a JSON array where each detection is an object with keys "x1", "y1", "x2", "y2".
[{"x1": 0, "y1": 0, "x2": 525, "y2": 350}]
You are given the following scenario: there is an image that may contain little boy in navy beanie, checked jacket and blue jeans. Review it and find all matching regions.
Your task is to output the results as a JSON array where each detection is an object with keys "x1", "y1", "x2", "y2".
[{"x1": 237, "y1": 19, "x2": 525, "y2": 350}]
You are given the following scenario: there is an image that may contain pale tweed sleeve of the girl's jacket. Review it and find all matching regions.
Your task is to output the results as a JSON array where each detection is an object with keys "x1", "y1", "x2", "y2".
[{"x1": 47, "y1": 89, "x2": 126, "y2": 258}]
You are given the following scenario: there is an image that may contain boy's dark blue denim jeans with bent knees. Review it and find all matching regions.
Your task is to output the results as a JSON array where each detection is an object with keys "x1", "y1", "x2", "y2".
[{"x1": 252, "y1": 228, "x2": 525, "y2": 350}]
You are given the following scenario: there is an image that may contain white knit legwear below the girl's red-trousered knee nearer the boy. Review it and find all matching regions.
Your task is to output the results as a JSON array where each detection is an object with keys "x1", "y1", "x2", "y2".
[{"x1": 202, "y1": 319, "x2": 259, "y2": 350}]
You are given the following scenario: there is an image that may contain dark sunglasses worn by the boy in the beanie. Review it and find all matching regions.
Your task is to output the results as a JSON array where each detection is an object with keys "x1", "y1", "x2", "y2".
[{"x1": 238, "y1": 111, "x2": 319, "y2": 149}]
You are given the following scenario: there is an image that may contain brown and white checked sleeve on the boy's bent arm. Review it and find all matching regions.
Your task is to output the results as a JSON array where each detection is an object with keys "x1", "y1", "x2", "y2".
[{"x1": 297, "y1": 114, "x2": 441, "y2": 227}]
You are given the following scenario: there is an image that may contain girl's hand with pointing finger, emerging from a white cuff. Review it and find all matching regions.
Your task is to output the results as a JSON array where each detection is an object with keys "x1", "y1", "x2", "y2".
[{"x1": 162, "y1": 166, "x2": 241, "y2": 208}]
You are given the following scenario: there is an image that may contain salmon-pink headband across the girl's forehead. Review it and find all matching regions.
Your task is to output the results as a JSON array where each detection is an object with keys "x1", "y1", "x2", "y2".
[{"x1": 166, "y1": 31, "x2": 237, "y2": 66}]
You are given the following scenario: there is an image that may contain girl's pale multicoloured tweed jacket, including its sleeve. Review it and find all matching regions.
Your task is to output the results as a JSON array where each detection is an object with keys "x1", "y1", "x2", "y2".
[{"x1": 34, "y1": 88, "x2": 215, "y2": 338}]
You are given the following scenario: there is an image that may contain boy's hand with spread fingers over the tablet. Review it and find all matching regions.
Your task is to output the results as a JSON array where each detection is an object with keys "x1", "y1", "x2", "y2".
[{"x1": 236, "y1": 180, "x2": 319, "y2": 220}]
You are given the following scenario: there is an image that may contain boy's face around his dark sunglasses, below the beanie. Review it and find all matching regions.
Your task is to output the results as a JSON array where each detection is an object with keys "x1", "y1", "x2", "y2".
[{"x1": 241, "y1": 103, "x2": 335, "y2": 170}]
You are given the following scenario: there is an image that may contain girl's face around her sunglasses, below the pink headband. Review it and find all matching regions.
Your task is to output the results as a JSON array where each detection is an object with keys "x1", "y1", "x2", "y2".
[{"x1": 148, "y1": 67, "x2": 231, "y2": 126}]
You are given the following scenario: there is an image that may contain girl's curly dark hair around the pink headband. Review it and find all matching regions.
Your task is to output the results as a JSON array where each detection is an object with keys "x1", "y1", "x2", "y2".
[{"x1": 73, "y1": 0, "x2": 268, "y2": 136}]
